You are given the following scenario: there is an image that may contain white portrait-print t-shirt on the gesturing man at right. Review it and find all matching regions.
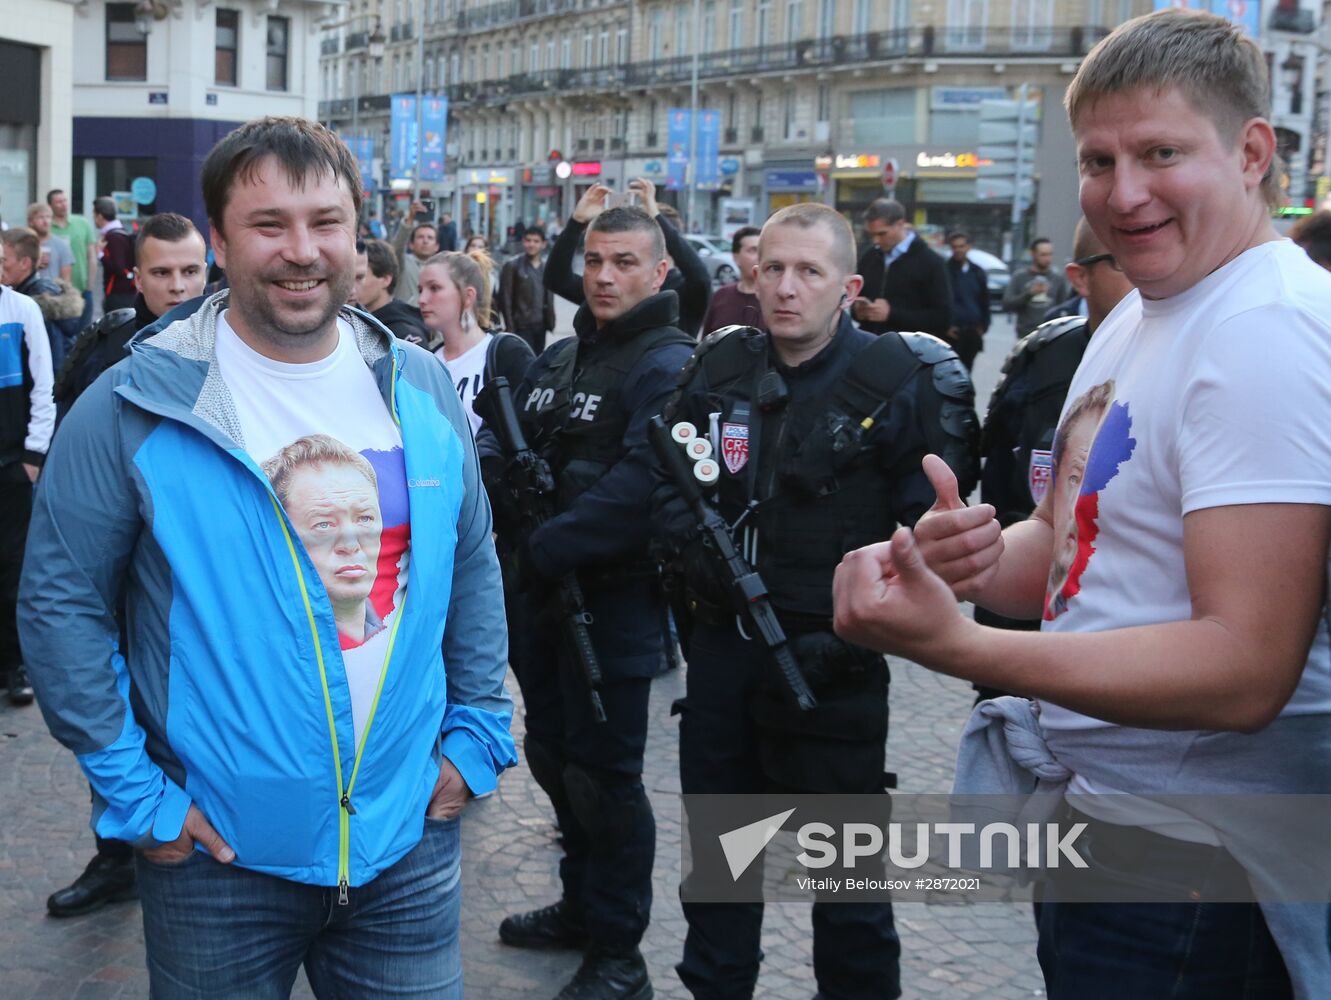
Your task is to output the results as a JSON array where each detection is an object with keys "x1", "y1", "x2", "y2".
[{"x1": 1040, "y1": 240, "x2": 1331, "y2": 843}]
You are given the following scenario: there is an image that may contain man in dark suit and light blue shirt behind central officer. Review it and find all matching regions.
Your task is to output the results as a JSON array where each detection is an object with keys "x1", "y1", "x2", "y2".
[{"x1": 851, "y1": 198, "x2": 952, "y2": 337}]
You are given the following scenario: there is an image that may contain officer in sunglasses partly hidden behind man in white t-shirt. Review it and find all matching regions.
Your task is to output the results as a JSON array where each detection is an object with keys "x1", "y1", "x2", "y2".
[{"x1": 962, "y1": 218, "x2": 1133, "y2": 699}]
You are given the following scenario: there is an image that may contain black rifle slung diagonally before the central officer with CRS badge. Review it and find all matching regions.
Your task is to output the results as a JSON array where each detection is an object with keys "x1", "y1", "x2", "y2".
[{"x1": 647, "y1": 415, "x2": 817, "y2": 711}]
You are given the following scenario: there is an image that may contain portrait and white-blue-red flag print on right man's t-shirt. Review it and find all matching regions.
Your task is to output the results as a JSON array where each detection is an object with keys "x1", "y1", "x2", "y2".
[{"x1": 1044, "y1": 379, "x2": 1137, "y2": 622}]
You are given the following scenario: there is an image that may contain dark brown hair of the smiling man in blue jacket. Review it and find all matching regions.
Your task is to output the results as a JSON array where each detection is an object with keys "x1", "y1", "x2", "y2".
[{"x1": 201, "y1": 117, "x2": 361, "y2": 232}]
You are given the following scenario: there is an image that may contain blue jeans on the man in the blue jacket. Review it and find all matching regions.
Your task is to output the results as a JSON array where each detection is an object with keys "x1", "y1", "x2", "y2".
[{"x1": 136, "y1": 819, "x2": 462, "y2": 1000}]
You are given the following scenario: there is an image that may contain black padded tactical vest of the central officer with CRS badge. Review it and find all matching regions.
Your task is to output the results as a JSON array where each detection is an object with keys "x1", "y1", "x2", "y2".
[{"x1": 699, "y1": 324, "x2": 977, "y2": 621}]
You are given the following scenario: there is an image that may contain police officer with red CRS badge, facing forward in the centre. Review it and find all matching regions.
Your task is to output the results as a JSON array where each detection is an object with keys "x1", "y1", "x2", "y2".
[{"x1": 654, "y1": 204, "x2": 978, "y2": 1000}]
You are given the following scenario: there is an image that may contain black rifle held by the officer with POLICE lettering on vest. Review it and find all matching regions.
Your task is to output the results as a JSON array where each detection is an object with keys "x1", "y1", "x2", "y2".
[{"x1": 473, "y1": 375, "x2": 606, "y2": 722}]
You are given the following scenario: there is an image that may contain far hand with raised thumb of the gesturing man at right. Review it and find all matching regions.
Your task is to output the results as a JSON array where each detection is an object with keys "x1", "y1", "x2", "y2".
[{"x1": 914, "y1": 455, "x2": 1002, "y2": 601}]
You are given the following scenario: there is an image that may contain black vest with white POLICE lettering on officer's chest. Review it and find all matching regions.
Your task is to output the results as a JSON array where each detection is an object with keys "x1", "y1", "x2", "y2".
[{"x1": 516, "y1": 326, "x2": 693, "y2": 510}]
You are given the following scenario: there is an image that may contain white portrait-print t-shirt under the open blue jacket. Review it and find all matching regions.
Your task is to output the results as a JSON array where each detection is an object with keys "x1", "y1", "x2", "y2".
[{"x1": 217, "y1": 312, "x2": 411, "y2": 746}]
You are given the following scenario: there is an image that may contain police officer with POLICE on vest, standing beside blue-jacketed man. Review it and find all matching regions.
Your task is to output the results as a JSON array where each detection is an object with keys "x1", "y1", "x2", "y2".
[{"x1": 499, "y1": 208, "x2": 695, "y2": 1000}]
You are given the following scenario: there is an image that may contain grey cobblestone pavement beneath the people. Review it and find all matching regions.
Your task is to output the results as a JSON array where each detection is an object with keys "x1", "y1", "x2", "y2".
[{"x1": 0, "y1": 314, "x2": 1042, "y2": 1000}]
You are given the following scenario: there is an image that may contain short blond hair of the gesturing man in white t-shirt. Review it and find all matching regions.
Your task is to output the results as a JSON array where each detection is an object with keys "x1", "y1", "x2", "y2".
[{"x1": 1063, "y1": 8, "x2": 1279, "y2": 201}]
